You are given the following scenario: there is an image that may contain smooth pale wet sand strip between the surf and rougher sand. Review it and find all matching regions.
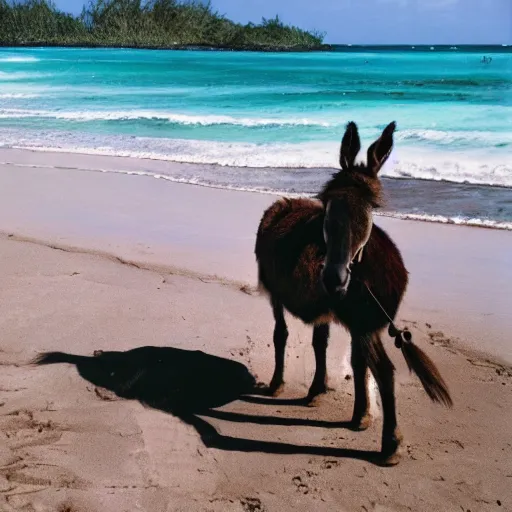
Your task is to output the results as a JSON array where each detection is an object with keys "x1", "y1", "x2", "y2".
[{"x1": 0, "y1": 150, "x2": 512, "y2": 361}]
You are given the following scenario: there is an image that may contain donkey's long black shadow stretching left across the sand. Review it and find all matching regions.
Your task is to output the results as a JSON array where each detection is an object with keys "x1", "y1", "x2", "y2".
[{"x1": 34, "y1": 346, "x2": 379, "y2": 463}]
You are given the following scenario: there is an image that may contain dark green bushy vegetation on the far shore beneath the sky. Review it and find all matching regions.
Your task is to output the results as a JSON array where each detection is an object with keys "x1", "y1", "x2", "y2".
[{"x1": 0, "y1": 0, "x2": 324, "y2": 49}]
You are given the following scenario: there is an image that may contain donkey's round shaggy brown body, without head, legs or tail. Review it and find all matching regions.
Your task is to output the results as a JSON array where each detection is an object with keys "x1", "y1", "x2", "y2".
[{"x1": 255, "y1": 199, "x2": 408, "y2": 332}]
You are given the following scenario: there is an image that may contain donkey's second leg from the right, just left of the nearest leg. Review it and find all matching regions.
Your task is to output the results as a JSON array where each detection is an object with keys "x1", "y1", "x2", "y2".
[{"x1": 350, "y1": 333, "x2": 372, "y2": 430}]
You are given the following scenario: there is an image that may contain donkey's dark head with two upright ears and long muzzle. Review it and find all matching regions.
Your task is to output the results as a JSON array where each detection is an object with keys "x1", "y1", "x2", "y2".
[{"x1": 318, "y1": 122, "x2": 396, "y2": 299}]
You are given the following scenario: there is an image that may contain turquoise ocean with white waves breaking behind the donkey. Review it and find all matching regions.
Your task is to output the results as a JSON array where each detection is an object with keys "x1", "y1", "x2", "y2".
[{"x1": 0, "y1": 46, "x2": 512, "y2": 229}]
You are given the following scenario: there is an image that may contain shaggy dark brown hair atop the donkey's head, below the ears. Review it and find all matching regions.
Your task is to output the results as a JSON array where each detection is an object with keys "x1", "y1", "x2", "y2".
[{"x1": 317, "y1": 168, "x2": 383, "y2": 208}]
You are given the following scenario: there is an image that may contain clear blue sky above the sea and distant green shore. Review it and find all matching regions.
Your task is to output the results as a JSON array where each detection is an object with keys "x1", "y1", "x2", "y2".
[{"x1": 54, "y1": 0, "x2": 512, "y2": 44}]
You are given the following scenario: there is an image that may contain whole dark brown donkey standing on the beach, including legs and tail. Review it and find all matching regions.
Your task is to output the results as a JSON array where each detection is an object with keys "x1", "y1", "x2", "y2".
[{"x1": 255, "y1": 122, "x2": 452, "y2": 464}]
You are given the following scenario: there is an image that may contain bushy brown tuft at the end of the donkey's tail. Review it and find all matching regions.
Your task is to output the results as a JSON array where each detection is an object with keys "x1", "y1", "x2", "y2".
[{"x1": 401, "y1": 339, "x2": 453, "y2": 407}]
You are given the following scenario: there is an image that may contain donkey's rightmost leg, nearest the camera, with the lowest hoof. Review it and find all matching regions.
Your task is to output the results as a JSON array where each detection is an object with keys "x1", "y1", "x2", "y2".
[{"x1": 361, "y1": 333, "x2": 403, "y2": 465}]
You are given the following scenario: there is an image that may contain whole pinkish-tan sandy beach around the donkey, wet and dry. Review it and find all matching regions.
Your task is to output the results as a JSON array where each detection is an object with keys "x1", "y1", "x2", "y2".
[{"x1": 0, "y1": 153, "x2": 512, "y2": 512}]
